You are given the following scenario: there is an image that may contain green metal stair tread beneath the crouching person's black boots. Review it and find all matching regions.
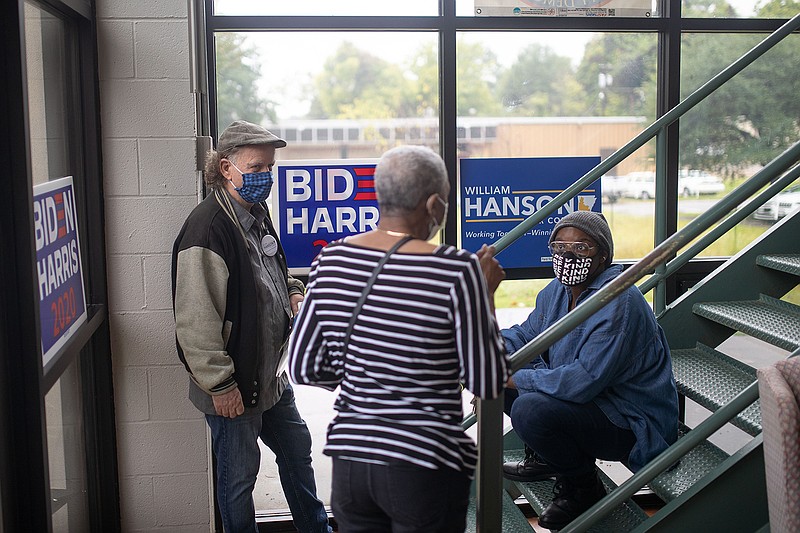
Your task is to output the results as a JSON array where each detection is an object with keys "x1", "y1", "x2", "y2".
[{"x1": 503, "y1": 449, "x2": 647, "y2": 533}]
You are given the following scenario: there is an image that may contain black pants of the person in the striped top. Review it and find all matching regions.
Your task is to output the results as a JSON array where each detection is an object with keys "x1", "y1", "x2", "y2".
[{"x1": 331, "y1": 458, "x2": 470, "y2": 533}]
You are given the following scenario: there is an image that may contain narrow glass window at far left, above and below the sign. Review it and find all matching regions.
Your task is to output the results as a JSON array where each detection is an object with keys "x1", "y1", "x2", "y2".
[{"x1": 25, "y1": 2, "x2": 89, "y2": 532}]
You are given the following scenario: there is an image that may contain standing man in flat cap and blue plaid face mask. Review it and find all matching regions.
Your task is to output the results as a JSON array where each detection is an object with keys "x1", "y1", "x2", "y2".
[{"x1": 172, "y1": 120, "x2": 331, "y2": 533}]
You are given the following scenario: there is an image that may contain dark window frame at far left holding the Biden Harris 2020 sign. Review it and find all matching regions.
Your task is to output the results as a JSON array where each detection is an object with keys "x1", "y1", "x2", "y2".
[{"x1": 0, "y1": 0, "x2": 120, "y2": 532}]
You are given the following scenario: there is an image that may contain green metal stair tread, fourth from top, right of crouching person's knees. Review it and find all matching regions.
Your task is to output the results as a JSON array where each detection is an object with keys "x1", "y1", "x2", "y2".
[{"x1": 650, "y1": 423, "x2": 728, "y2": 502}]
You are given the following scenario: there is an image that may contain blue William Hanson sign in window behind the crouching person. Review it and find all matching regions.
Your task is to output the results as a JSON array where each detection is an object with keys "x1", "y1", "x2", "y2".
[{"x1": 460, "y1": 157, "x2": 602, "y2": 268}]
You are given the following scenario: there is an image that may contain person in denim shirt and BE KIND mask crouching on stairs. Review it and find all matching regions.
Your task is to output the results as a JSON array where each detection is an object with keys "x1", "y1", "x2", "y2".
[{"x1": 501, "y1": 211, "x2": 678, "y2": 530}]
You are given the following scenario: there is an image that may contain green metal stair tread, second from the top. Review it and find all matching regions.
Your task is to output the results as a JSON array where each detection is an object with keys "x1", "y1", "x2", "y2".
[{"x1": 692, "y1": 294, "x2": 800, "y2": 352}]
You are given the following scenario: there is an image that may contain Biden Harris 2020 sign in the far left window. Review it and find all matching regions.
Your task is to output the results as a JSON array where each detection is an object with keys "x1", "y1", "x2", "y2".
[{"x1": 33, "y1": 176, "x2": 86, "y2": 365}]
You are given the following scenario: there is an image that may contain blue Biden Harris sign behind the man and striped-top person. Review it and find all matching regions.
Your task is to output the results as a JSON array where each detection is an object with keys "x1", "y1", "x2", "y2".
[{"x1": 273, "y1": 159, "x2": 379, "y2": 274}]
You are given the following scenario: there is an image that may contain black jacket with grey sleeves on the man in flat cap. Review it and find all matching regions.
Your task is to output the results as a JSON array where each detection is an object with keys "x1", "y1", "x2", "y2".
[{"x1": 172, "y1": 192, "x2": 303, "y2": 407}]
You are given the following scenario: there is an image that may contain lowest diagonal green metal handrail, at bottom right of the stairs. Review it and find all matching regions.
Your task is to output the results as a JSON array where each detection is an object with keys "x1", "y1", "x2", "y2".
[{"x1": 561, "y1": 348, "x2": 800, "y2": 533}]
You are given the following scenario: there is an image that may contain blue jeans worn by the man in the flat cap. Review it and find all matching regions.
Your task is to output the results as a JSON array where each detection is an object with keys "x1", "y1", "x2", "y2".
[{"x1": 206, "y1": 385, "x2": 331, "y2": 533}]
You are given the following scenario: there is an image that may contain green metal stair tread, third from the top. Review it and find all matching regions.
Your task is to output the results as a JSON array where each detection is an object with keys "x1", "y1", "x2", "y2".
[{"x1": 672, "y1": 343, "x2": 761, "y2": 435}]
